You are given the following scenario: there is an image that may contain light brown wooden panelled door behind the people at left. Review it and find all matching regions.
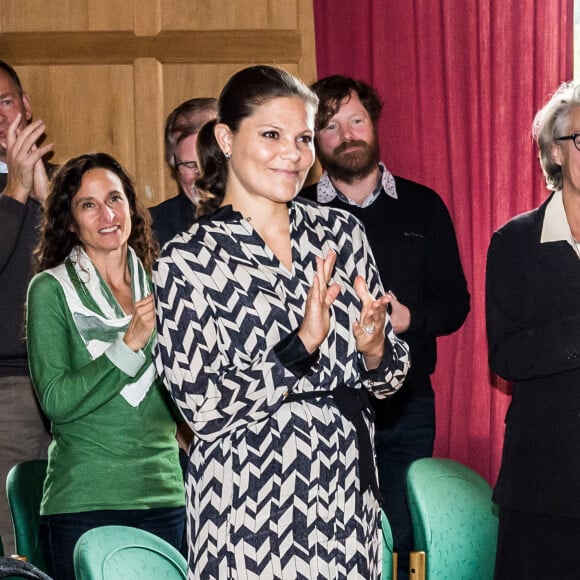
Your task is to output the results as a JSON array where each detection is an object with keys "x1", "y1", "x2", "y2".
[{"x1": 0, "y1": 0, "x2": 316, "y2": 206}]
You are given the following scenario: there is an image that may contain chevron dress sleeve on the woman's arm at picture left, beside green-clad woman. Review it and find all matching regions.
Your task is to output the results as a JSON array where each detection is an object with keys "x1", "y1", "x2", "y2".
[{"x1": 153, "y1": 254, "x2": 309, "y2": 440}]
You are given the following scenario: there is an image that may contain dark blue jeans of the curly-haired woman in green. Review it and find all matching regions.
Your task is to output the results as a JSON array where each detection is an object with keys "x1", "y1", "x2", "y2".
[{"x1": 40, "y1": 507, "x2": 185, "y2": 580}]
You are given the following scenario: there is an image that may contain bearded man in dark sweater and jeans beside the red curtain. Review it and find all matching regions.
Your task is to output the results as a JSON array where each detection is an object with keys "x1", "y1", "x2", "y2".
[{"x1": 301, "y1": 75, "x2": 470, "y2": 579}]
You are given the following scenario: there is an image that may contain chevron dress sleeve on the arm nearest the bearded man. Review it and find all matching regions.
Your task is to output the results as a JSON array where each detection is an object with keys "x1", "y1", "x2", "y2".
[{"x1": 352, "y1": 218, "x2": 411, "y2": 399}]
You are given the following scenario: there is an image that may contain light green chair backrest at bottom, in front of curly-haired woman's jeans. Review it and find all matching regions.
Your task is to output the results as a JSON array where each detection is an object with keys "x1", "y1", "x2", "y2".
[{"x1": 74, "y1": 526, "x2": 187, "y2": 580}]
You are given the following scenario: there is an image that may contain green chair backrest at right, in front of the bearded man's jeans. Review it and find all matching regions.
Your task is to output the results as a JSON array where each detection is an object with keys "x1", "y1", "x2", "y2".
[{"x1": 407, "y1": 458, "x2": 498, "y2": 580}]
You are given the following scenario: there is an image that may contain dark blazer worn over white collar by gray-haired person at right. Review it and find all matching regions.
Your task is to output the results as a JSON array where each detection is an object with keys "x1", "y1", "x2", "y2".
[{"x1": 486, "y1": 191, "x2": 580, "y2": 517}]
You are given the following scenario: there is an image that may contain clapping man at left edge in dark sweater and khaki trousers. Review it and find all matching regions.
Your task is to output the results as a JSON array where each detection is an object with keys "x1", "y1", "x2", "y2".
[{"x1": 0, "y1": 61, "x2": 52, "y2": 554}]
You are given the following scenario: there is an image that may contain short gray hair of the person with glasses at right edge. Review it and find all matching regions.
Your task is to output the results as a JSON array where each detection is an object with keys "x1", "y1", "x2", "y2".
[{"x1": 532, "y1": 81, "x2": 580, "y2": 191}]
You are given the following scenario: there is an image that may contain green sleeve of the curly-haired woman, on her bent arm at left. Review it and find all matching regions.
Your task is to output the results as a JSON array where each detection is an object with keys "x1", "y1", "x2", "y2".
[{"x1": 26, "y1": 273, "x2": 151, "y2": 423}]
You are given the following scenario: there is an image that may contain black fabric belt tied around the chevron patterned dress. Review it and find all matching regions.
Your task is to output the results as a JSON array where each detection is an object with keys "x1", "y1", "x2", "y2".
[{"x1": 284, "y1": 384, "x2": 383, "y2": 503}]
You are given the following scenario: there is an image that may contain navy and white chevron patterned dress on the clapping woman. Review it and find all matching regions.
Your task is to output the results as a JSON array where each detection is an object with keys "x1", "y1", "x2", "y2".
[{"x1": 153, "y1": 201, "x2": 409, "y2": 580}]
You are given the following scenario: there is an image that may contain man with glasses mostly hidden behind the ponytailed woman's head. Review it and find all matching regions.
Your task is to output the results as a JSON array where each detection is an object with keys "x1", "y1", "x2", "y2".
[{"x1": 149, "y1": 98, "x2": 217, "y2": 246}]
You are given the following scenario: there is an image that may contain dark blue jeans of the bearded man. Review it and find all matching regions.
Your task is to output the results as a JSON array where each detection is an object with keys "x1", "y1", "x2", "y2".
[{"x1": 375, "y1": 385, "x2": 435, "y2": 580}]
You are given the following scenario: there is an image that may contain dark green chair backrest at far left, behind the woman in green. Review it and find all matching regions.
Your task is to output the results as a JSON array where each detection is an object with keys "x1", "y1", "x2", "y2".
[{"x1": 6, "y1": 459, "x2": 48, "y2": 571}]
